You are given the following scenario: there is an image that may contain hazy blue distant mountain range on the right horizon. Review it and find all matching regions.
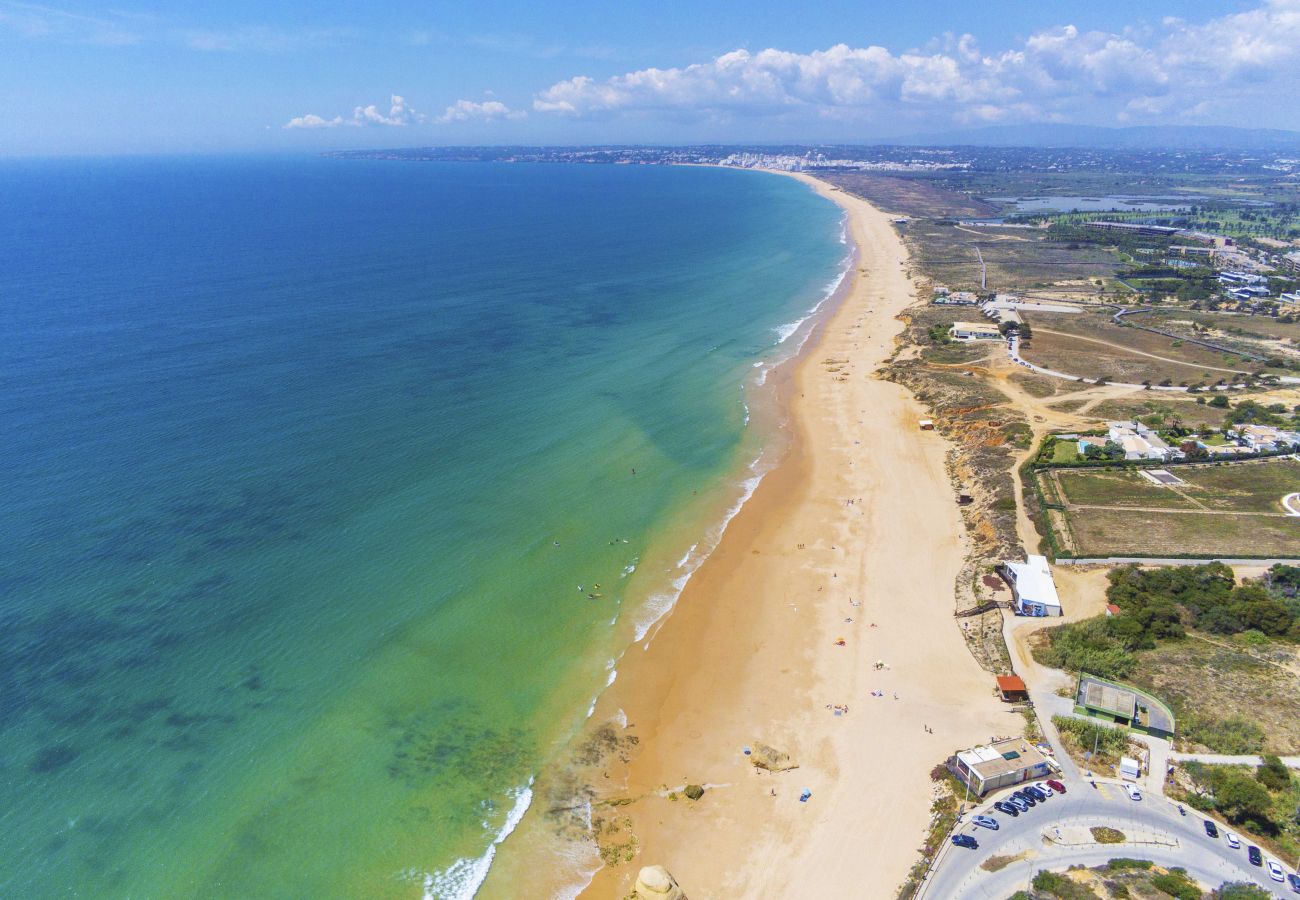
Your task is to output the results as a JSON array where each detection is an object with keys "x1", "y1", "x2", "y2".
[{"x1": 879, "y1": 124, "x2": 1300, "y2": 151}]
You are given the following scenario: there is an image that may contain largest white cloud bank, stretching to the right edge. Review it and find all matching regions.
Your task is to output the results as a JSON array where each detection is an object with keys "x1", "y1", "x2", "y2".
[{"x1": 533, "y1": 0, "x2": 1300, "y2": 125}]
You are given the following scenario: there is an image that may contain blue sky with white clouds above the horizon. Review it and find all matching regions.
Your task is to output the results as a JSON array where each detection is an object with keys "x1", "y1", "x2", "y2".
[{"x1": 0, "y1": 0, "x2": 1300, "y2": 155}]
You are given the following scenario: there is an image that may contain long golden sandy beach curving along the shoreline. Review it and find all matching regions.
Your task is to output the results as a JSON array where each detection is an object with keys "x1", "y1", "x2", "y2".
[{"x1": 584, "y1": 176, "x2": 1022, "y2": 900}]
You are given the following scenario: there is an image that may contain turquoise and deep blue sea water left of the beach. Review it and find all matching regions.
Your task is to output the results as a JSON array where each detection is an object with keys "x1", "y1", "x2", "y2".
[{"x1": 0, "y1": 159, "x2": 844, "y2": 897}]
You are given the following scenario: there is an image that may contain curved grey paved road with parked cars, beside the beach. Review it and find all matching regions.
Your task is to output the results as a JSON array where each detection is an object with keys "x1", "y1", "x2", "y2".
[{"x1": 919, "y1": 782, "x2": 1294, "y2": 900}]
